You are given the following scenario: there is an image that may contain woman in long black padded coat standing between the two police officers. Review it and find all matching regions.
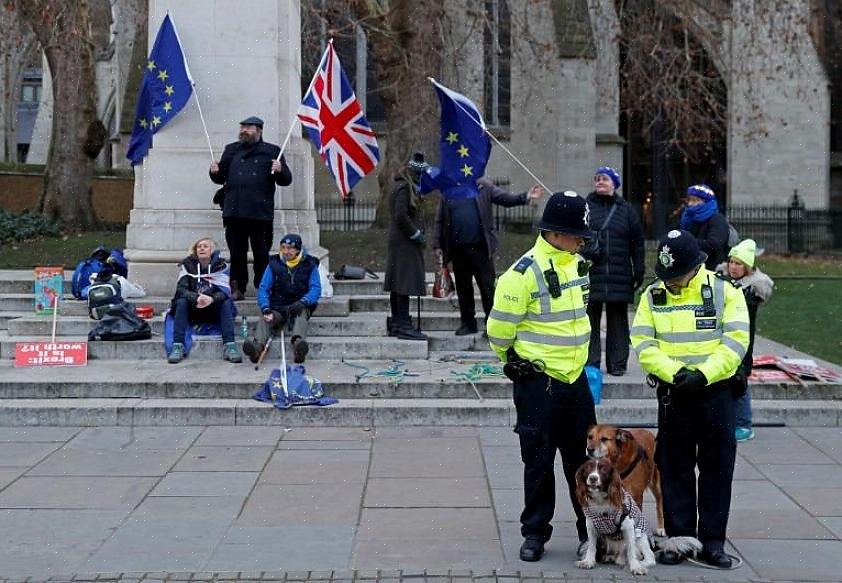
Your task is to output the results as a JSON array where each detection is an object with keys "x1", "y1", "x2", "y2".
[{"x1": 583, "y1": 166, "x2": 645, "y2": 376}]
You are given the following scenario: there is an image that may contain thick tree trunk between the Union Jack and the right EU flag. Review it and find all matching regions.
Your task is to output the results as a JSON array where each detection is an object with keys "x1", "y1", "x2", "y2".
[{"x1": 353, "y1": 0, "x2": 444, "y2": 228}]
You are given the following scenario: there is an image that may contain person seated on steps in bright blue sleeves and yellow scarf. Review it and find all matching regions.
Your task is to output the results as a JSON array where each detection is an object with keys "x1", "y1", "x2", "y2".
[{"x1": 243, "y1": 233, "x2": 322, "y2": 363}]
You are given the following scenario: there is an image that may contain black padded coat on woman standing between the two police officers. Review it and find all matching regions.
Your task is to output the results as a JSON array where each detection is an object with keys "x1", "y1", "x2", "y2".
[{"x1": 583, "y1": 192, "x2": 645, "y2": 303}]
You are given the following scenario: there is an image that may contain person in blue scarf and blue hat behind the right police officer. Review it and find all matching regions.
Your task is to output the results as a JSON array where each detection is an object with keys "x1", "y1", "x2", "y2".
[{"x1": 681, "y1": 184, "x2": 730, "y2": 271}]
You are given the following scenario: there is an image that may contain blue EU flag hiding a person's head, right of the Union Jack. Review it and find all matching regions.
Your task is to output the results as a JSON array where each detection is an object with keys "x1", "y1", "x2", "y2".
[{"x1": 421, "y1": 79, "x2": 491, "y2": 198}]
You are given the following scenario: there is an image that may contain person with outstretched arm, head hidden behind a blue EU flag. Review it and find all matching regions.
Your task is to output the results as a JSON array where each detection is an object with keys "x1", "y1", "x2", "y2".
[{"x1": 433, "y1": 178, "x2": 544, "y2": 336}]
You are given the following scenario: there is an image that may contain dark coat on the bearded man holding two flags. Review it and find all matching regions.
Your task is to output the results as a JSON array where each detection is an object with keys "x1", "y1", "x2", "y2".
[{"x1": 209, "y1": 140, "x2": 292, "y2": 221}]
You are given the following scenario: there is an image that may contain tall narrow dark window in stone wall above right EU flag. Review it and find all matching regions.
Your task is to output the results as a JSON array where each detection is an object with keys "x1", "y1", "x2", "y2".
[{"x1": 483, "y1": 0, "x2": 512, "y2": 126}]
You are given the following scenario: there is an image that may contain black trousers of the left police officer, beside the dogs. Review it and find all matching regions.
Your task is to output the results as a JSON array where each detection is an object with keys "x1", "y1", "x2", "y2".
[{"x1": 514, "y1": 374, "x2": 596, "y2": 542}]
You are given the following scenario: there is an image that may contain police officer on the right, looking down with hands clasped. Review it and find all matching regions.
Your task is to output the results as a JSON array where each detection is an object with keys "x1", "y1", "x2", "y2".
[{"x1": 631, "y1": 230, "x2": 749, "y2": 568}]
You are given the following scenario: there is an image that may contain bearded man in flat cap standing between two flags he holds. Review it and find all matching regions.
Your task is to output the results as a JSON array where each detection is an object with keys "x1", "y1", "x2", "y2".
[{"x1": 210, "y1": 116, "x2": 292, "y2": 300}]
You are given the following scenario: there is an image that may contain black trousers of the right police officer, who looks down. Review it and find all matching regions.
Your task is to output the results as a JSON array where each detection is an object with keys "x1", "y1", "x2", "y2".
[{"x1": 655, "y1": 379, "x2": 737, "y2": 550}]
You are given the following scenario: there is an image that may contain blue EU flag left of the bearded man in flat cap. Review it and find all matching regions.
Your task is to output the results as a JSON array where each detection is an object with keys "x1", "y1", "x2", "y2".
[{"x1": 126, "y1": 14, "x2": 193, "y2": 166}]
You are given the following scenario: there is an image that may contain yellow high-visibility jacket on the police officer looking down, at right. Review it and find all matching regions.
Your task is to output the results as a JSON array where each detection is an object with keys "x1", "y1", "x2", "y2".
[{"x1": 631, "y1": 266, "x2": 749, "y2": 384}]
